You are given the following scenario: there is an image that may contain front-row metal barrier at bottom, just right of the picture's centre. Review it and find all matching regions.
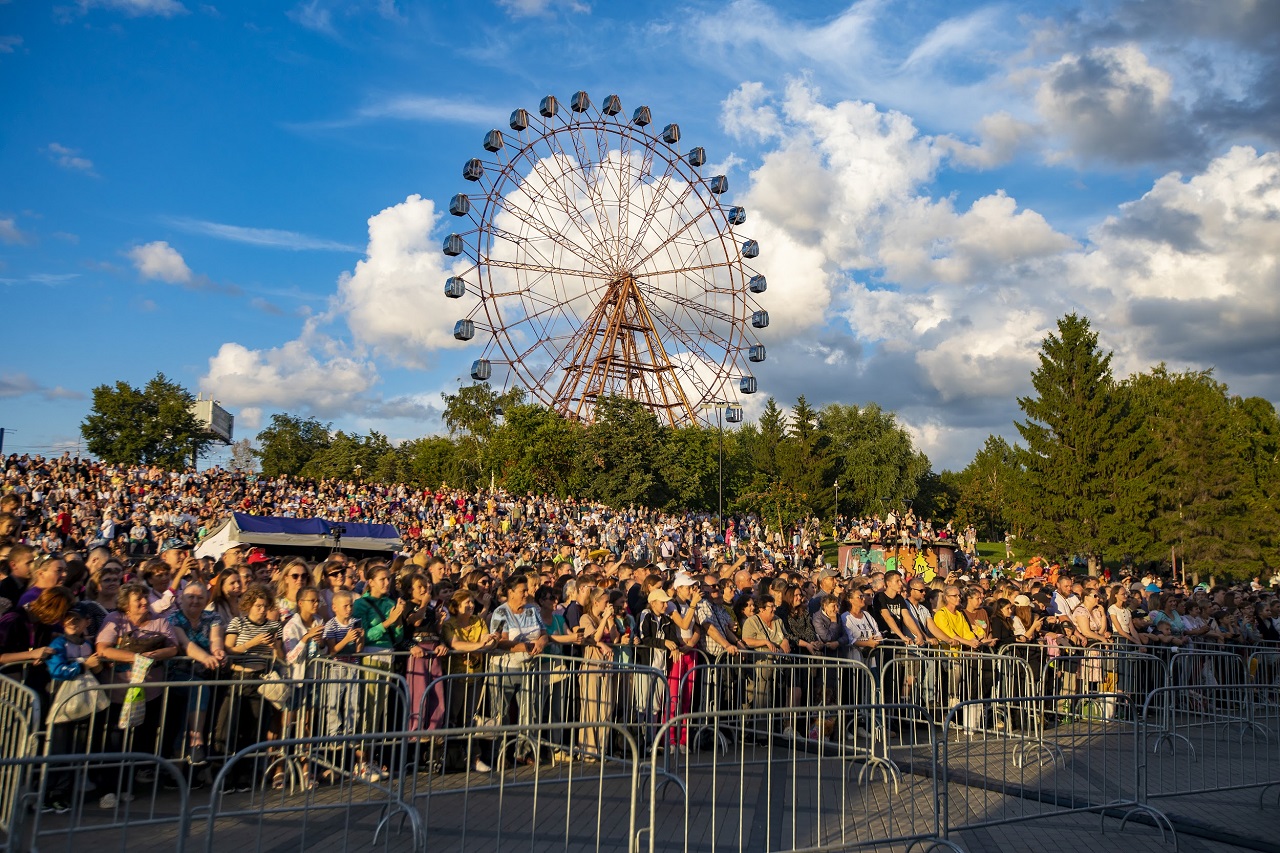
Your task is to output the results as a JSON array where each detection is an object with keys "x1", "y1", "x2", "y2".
[{"x1": 636, "y1": 703, "x2": 957, "y2": 853}]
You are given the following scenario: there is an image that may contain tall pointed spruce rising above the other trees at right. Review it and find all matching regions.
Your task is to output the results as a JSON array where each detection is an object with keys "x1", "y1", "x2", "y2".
[{"x1": 1015, "y1": 314, "x2": 1115, "y2": 556}]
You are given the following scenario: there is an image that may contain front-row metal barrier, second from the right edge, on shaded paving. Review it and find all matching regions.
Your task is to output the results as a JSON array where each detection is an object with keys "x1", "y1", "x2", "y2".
[{"x1": 938, "y1": 693, "x2": 1172, "y2": 836}]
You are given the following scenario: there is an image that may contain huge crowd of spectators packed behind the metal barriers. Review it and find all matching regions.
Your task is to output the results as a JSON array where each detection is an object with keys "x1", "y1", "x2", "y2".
[{"x1": 0, "y1": 456, "x2": 1280, "y2": 811}]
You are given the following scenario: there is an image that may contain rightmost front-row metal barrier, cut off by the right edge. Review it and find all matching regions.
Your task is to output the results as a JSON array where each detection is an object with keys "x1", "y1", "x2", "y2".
[{"x1": 1143, "y1": 684, "x2": 1280, "y2": 799}]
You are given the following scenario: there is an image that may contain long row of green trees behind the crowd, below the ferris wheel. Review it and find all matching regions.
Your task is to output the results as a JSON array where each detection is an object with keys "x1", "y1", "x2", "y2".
[{"x1": 256, "y1": 384, "x2": 940, "y2": 526}]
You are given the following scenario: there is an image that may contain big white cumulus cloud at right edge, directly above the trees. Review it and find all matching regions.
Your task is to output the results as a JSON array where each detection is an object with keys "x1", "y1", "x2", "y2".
[{"x1": 1075, "y1": 146, "x2": 1280, "y2": 381}]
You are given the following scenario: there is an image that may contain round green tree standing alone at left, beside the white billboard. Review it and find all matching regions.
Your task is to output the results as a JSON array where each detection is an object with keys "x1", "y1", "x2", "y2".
[{"x1": 81, "y1": 373, "x2": 216, "y2": 469}]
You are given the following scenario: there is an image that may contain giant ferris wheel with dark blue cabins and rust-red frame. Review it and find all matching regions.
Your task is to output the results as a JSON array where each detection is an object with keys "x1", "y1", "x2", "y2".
[{"x1": 444, "y1": 91, "x2": 769, "y2": 425}]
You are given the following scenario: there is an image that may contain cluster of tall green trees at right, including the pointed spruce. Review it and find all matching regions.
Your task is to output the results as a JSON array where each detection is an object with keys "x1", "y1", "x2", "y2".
[{"x1": 942, "y1": 314, "x2": 1280, "y2": 578}]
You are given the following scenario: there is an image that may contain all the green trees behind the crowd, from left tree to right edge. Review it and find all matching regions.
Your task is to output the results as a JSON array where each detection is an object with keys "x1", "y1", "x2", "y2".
[{"x1": 82, "y1": 314, "x2": 1280, "y2": 576}]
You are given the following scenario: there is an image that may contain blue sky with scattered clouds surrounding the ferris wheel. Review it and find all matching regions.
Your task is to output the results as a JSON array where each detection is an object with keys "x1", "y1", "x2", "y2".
[{"x1": 0, "y1": 0, "x2": 1280, "y2": 467}]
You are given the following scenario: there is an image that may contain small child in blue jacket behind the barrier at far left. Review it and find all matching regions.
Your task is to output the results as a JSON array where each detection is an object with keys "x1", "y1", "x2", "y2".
[{"x1": 44, "y1": 603, "x2": 105, "y2": 815}]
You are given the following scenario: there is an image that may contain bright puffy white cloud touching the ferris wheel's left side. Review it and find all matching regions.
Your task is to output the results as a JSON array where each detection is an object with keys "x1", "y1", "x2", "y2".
[{"x1": 337, "y1": 195, "x2": 475, "y2": 368}]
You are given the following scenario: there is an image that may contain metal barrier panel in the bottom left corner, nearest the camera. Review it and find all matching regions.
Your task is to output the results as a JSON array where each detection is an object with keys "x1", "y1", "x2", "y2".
[{"x1": 0, "y1": 752, "x2": 191, "y2": 853}]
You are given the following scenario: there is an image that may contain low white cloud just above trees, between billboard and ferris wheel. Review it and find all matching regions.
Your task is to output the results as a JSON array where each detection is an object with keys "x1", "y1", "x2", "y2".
[{"x1": 200, "y1": 320, "x2": 379, "y2": 418}]
